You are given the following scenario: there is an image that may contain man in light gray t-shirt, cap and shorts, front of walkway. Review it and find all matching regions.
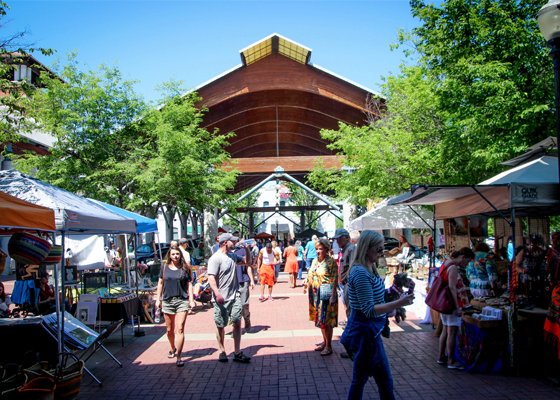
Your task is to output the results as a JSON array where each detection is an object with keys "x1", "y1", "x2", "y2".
[{"x1": 207, "y1": 233, "x2": 251, "y2": 363}]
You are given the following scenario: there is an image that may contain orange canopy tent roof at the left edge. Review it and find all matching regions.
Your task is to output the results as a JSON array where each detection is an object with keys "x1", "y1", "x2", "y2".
[{"x1": 0, "y1": 192, "x2": 56, "y2": 231}]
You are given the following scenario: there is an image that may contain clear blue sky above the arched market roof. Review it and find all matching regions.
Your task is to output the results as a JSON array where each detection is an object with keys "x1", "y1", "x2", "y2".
[{"x1": 3, "y1": 0, "x2": 418, "y2": 101}]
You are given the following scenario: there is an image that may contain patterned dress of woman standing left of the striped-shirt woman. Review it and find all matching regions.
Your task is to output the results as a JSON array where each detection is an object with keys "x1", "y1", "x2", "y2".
[{"x1": 307, "y1": 257, "x2": 338, "y2": 328}]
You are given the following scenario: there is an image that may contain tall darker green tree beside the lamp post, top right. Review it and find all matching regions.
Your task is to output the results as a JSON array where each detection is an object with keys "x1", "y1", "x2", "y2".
[{"x1": 403, "y1": 0, "x2": 554, "y2": 183}]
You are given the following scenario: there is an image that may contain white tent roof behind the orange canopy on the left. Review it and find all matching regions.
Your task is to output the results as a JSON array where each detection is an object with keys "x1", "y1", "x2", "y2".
[{"x1": 0, "y1": 170, "x2": 136, "y2": 234}]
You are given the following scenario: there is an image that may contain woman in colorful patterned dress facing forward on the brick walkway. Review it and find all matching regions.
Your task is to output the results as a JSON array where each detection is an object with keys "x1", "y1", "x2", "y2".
[{"x1": 303, "y1": 238, "x2": 338, "y2": 356}]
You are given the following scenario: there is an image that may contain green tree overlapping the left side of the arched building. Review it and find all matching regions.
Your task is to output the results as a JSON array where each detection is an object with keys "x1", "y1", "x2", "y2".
[{"x1": 134, "y1": 85, "x2": 237, "y2": 227}]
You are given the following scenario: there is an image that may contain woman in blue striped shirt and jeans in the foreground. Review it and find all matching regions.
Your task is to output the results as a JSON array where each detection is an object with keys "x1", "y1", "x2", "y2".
[{"x1": 340, "y1": 230, "x2": 414, "y2": 400}]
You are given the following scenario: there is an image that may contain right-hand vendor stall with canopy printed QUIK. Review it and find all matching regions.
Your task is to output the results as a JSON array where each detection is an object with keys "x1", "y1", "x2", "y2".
[{"x1": 389, "y1": 156, "x2": 560, "y2": 372}]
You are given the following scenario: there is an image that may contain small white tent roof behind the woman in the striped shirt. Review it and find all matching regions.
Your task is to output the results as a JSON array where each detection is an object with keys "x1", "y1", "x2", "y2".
[{"x1": 350, "y1": 200, "x2": 434, "y2": 230}]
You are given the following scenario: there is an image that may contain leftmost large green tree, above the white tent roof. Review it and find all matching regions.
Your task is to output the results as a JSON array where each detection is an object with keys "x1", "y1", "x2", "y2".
[{"x1": 18, "y1": 55, "x2": 145, "y2": 207}]
